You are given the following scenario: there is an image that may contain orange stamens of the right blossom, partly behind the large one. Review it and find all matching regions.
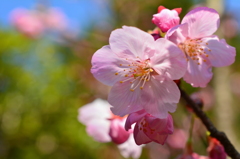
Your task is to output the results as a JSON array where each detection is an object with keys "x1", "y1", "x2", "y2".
[{"x1": 178, "y1": 39, "x2": 211, "y2": 65}]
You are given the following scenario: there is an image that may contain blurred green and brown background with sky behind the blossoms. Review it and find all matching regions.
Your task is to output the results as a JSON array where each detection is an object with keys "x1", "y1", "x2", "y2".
[{"x1": 0, "y1": 0, "x2": 240, "y2": 159}]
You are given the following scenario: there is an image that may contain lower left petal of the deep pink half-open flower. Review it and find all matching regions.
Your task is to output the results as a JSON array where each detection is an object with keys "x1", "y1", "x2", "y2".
[{"x1": 133, "y1": 123, "x2": 152, "y2": 145}]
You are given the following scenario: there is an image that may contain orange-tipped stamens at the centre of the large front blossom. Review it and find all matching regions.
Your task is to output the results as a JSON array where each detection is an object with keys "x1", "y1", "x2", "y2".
[{"x1": 115, "y1": 59, "x2": 154, "y2": 92}]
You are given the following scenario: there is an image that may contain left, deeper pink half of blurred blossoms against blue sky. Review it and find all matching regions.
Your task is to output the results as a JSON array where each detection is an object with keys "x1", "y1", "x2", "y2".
[{"x1": 11, "y1": 9, "x2": 44, "y2": 38}]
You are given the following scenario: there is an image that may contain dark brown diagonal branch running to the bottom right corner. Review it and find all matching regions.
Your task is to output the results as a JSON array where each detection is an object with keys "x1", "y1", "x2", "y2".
[{"x1": 180, "y1": 88, "x2": 240, "y2": 159}]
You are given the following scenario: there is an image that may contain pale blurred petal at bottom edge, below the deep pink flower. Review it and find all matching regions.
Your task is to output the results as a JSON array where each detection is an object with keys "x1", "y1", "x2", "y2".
[{"x1": 118, "y1": 134, "x2": 142, "y2": 159}]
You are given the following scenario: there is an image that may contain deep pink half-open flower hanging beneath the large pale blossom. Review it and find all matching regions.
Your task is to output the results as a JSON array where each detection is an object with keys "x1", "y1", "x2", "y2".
[{"x1": 125, "y1": 110, "x2": 173, "y2": 145}]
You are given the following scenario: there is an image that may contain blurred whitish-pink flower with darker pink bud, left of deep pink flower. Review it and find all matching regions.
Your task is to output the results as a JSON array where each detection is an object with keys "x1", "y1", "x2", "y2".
[{"x1": 78, "y1": 99, "x2": 132, "y2": 144}]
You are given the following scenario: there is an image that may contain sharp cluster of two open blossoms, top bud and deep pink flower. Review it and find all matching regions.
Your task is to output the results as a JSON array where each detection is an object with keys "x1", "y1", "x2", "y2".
[{"x1": 85, "y1": 6, "x2": 236, "y2": 158}]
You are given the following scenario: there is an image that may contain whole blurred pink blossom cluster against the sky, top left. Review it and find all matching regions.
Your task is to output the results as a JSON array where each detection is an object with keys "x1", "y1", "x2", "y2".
[{"x1": 11, "y1": 8, "x2": 67, "y2": 38}]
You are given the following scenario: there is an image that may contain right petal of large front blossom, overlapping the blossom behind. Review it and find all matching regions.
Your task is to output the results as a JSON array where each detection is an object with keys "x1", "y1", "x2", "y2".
[{"x1": 151, "y1": 38, "x2": 187, "y2": 80}]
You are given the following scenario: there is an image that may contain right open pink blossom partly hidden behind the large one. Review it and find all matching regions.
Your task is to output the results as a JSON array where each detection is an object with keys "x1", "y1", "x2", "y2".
[{"x1": 166, "y1": 7, "x2": 236, "y2": 87}]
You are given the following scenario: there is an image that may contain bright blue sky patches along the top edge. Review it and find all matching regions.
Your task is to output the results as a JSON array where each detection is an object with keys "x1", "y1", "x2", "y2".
[{"x1": 0, "y1": 0, "x2": 240, "y2": 28}]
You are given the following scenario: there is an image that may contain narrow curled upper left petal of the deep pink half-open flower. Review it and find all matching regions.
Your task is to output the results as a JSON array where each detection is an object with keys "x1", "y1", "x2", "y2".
[{"x1": 125, "y1": 109, "x2": 147, "y2": 130}]
